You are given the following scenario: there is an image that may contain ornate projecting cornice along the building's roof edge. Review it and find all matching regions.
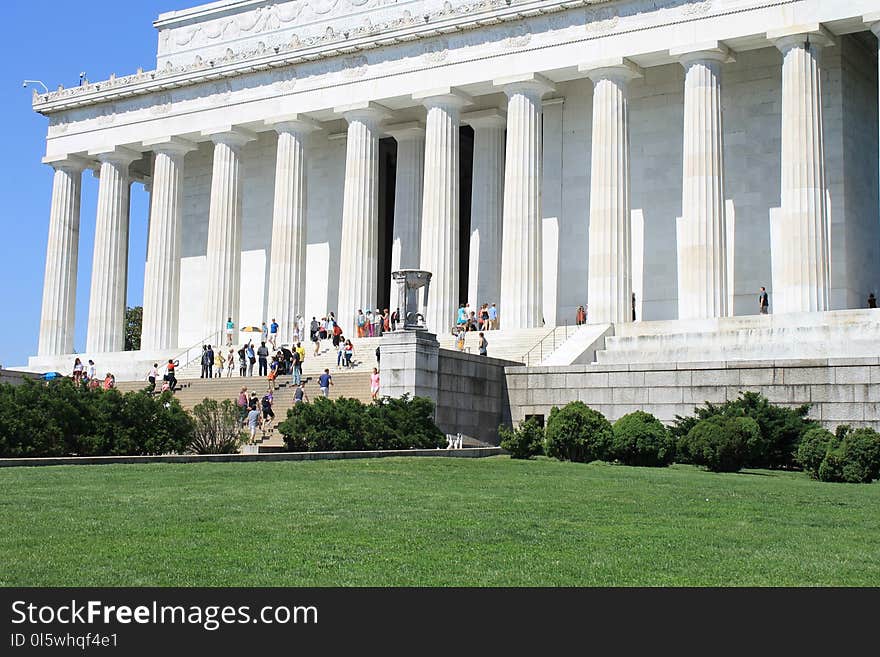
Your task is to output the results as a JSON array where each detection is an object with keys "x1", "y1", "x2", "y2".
[{"x1": 33, "y1": 0, "x2": 611, "y2": 115}]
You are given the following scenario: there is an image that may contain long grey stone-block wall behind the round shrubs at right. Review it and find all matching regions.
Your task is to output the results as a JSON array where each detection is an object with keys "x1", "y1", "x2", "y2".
[{"x1": 506, "y1": 358, "x2": 880, "y2": 429}]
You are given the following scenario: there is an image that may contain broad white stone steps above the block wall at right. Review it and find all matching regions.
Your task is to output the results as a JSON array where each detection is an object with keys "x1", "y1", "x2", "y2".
[{"x1": 596, "y1": 309, "x2": 880, "y2": 365}]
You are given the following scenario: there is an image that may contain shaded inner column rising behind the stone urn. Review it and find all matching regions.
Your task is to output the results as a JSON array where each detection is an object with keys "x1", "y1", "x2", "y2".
[{"x1": 385, "y1": 122, "x2": 425, "y2": 304}]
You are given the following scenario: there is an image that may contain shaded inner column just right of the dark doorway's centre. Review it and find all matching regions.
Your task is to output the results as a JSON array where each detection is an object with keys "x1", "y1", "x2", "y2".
[{"x1": 462, "y1": 110, "x2": 507, "y2": 312}]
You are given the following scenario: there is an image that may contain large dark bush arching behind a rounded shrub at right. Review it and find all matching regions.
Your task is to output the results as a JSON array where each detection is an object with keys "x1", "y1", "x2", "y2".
[{"x1": 670, "y1": 392, "x2": 819, "y2": 469}]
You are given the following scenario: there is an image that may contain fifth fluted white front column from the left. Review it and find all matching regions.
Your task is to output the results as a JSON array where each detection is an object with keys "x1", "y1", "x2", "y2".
[{"x1": 267, "y1": 116, "x2": 319, "y2": 341}]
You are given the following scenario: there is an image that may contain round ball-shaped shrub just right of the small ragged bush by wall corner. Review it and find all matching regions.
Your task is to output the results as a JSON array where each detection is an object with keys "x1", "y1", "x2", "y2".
[{"x1": 544, "y1": 401, "x2": 612, "y2": 463}]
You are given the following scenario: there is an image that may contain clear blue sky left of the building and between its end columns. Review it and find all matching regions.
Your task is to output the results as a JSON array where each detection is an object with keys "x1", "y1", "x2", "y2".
[{"x1": 0, "y1": 0, "x2": 177, "y2": 367}]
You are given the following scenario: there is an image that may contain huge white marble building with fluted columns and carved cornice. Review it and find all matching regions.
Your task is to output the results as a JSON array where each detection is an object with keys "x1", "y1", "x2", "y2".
[{"x1": 29, "y1": 0, "x2": 880, "y2": 375}]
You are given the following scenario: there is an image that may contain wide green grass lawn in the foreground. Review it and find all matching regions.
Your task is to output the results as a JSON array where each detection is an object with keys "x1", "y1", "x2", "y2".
[{"x1": 0, "y1": 457, "x2": 880, "y2": 586}]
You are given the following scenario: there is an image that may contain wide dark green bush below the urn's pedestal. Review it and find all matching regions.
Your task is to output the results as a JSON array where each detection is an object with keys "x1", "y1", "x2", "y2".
[{"x1": 278, "y1": 395, "x2": 445, "y2": 452}]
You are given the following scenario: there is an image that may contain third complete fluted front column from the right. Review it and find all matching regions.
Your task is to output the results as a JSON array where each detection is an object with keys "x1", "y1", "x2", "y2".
[{"x1": 580, "y1": 59, "x2": 641, "y2": 324}]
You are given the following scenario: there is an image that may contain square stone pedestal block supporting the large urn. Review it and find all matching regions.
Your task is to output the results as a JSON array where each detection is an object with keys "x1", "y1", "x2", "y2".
[{"x1": 381, "y1": 331, "x2": 440, "y2": 403}]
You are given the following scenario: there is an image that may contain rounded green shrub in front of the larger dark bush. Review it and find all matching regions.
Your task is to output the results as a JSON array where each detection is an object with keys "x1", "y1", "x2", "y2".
[{"x1": 679, "y1": 415, "x2": 762, "y2": 472}]
